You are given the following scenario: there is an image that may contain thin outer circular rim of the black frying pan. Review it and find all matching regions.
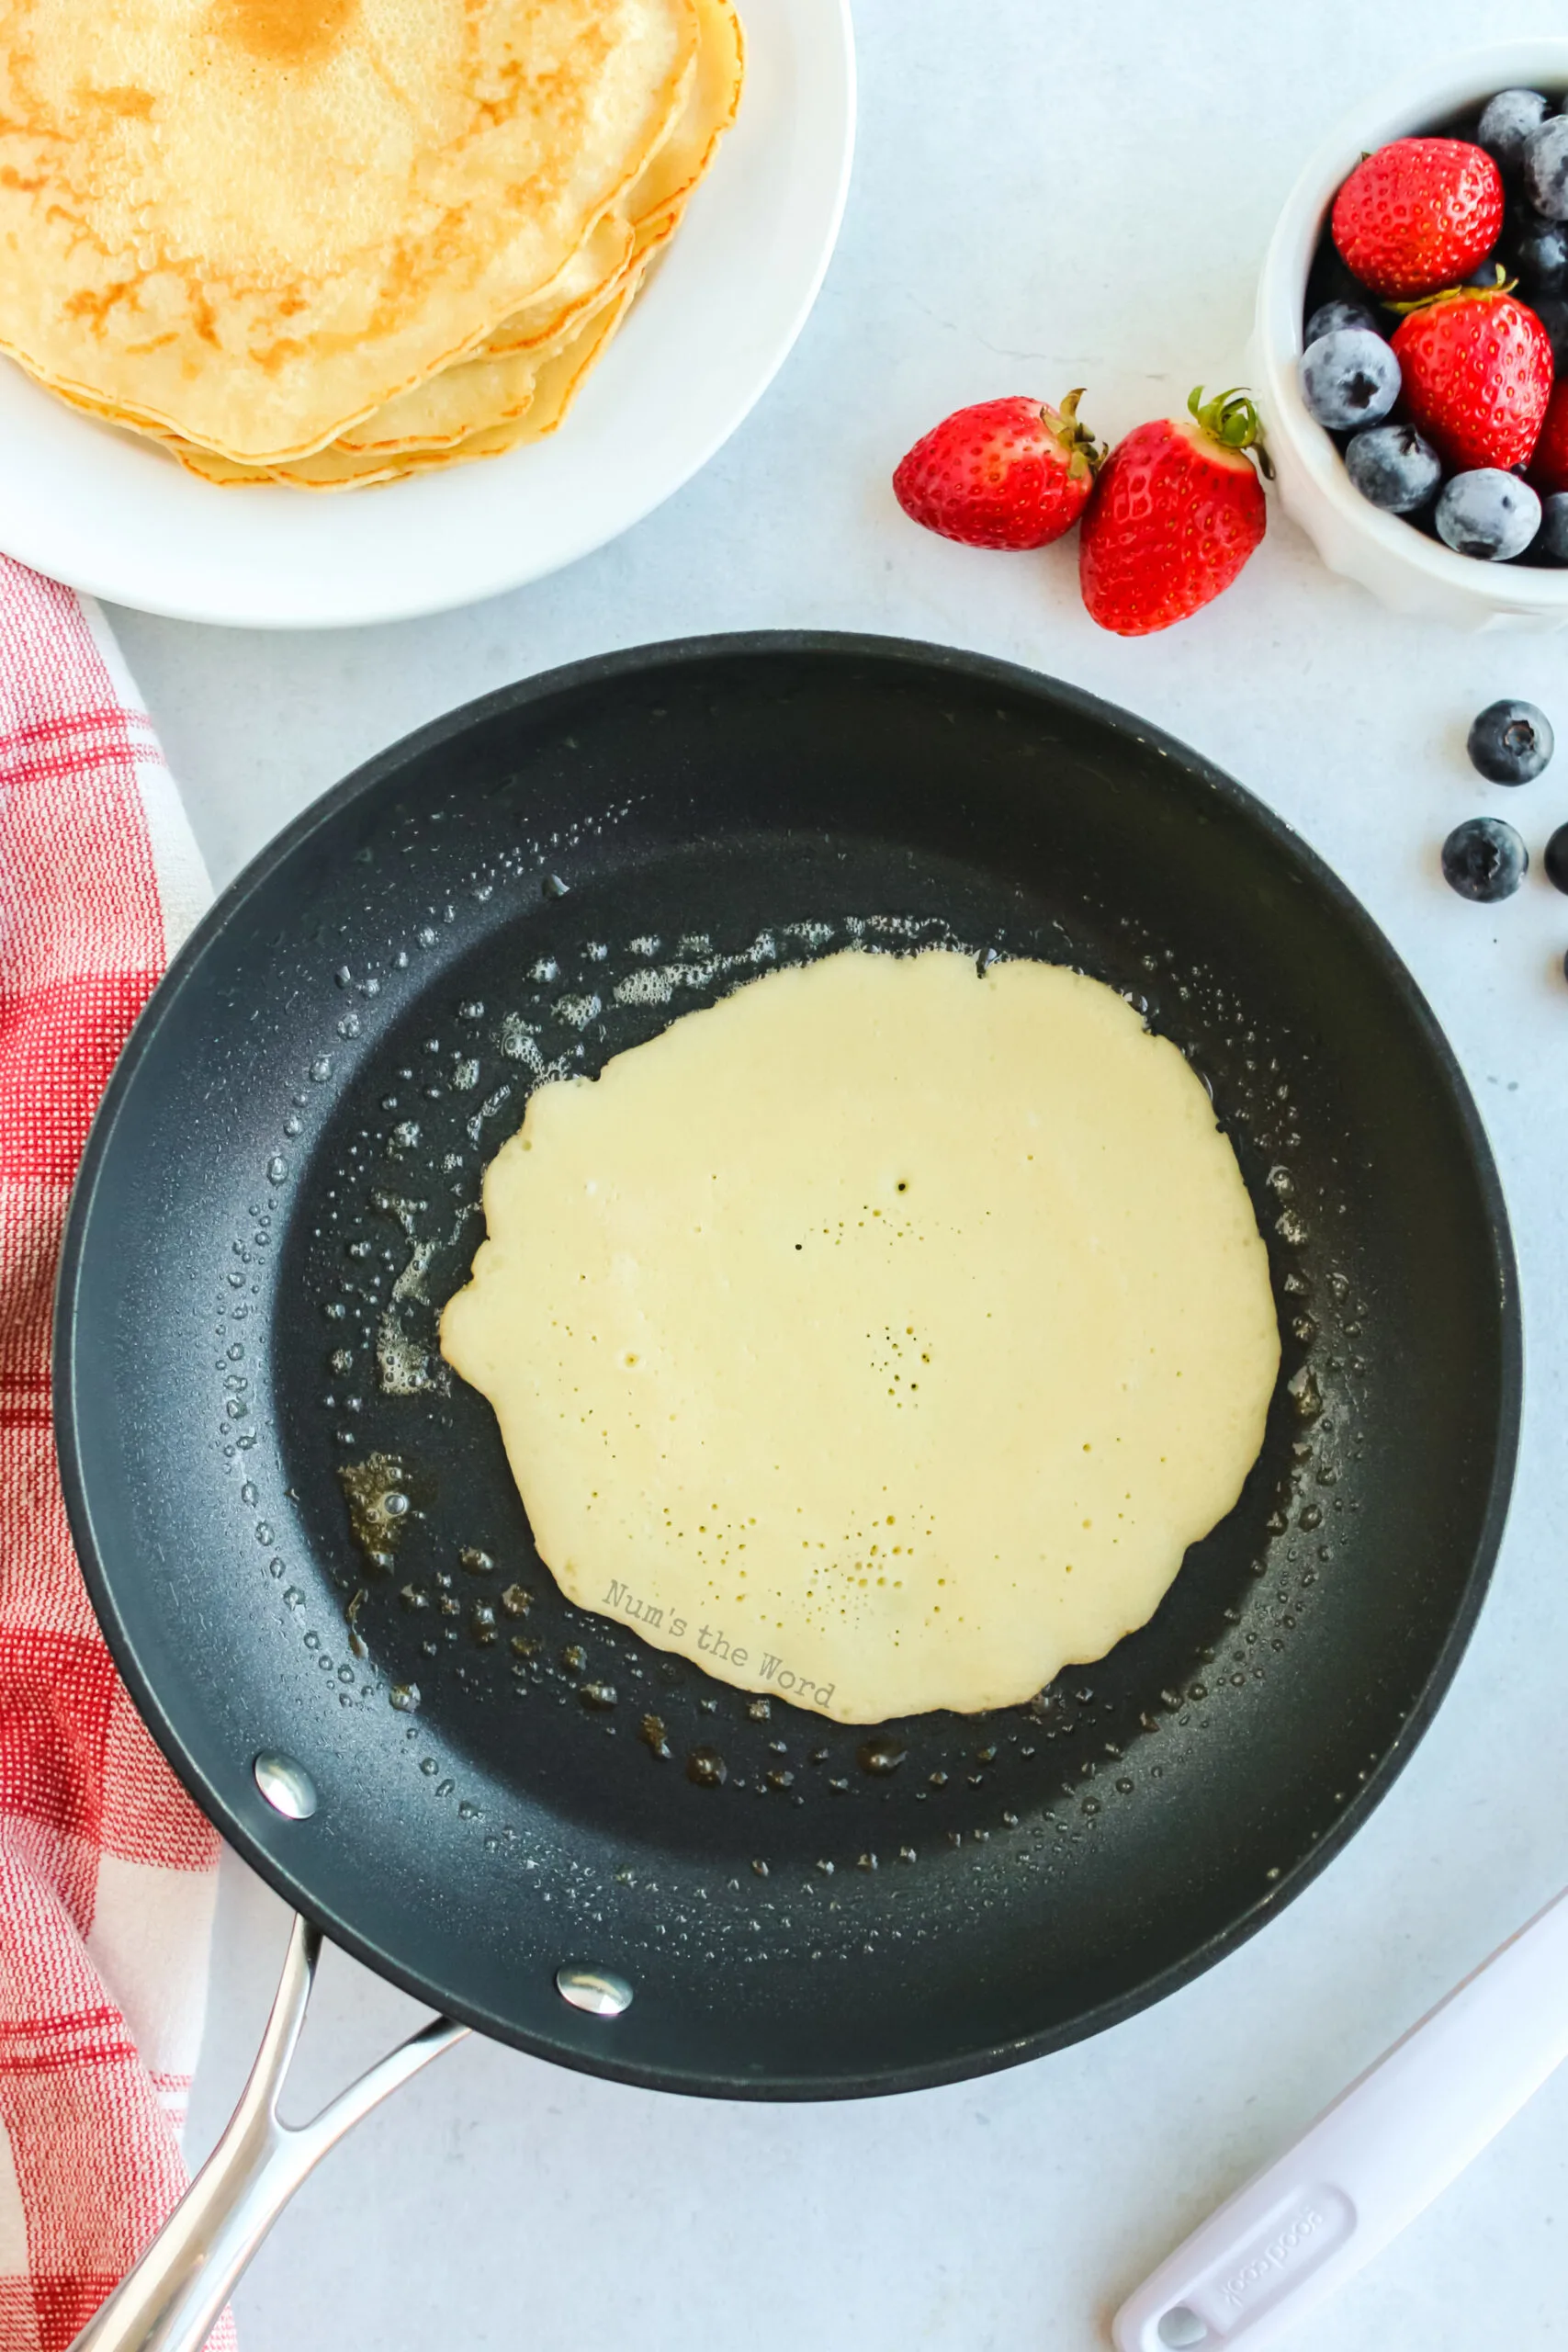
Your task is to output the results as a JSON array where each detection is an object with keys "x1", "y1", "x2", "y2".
[{"x1": 51, "y1": 630, "x2": 1523, "y2": 2103}]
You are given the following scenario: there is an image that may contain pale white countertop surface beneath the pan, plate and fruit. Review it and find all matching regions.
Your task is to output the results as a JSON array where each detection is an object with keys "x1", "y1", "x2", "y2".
[{"x1": 115, "y1": 0, "x2": 1568, "y2": 2352}]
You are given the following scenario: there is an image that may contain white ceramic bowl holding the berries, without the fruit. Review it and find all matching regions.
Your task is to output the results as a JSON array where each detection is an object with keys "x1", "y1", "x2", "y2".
[{"x1": 1253, "y1": 40, "x2": 1568, "y2": 628}]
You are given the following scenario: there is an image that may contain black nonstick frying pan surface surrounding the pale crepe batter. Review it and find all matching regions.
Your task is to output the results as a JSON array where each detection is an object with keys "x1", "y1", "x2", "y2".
[{"x1": 56, "y1": 635, "x2": 1518, "y2": 2324}]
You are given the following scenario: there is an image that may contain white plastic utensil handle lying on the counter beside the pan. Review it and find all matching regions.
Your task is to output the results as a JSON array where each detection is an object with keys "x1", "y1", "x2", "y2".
[{"x1": 1112, "y1": 1894, "x2": 1568, "y2": 2352}]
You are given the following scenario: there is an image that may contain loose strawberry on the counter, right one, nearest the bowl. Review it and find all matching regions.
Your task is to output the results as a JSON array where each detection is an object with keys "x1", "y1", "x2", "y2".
[{"x1": 1079, "y1": 388, "x2": 1267, "y2": 638}]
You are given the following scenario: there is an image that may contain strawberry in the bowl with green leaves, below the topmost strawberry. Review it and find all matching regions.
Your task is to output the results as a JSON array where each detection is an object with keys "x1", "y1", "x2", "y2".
[{"x1": 1394, "y1": 287, "x2": 1551, "y2": 473}]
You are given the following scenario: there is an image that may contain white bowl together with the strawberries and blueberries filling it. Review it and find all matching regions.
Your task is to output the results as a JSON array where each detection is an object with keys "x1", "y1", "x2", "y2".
[{"x1": 1253, "y1": 40, "x2": 1568, "y2": 628}]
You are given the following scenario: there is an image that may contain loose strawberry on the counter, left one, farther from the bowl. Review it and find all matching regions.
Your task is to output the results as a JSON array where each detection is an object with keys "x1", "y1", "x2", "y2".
[{"x1": 894, "y1": 390, "x2": 1105, "y2": 548}]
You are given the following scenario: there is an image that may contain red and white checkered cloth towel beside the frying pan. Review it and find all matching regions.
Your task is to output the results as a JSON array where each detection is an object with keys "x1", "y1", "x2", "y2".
[{"x1": 0, "y1": 558, "x2": 228, "y2": 2352}]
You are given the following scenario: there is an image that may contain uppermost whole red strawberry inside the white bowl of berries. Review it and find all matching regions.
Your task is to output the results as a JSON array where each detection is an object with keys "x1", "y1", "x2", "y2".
[{"x1": 1331, "y1": 139, "x2": 1502, "y2": 297}]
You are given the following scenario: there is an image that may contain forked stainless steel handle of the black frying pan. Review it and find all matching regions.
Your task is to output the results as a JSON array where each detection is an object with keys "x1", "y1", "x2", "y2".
[{"x1": 71, "y1": 1919, "x2": 468, "y2": 2352}]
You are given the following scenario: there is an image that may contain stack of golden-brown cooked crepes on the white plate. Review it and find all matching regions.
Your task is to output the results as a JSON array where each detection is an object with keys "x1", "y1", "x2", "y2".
[{"x1": 0, "y1": 0, "x2": 743, "y2": 489}]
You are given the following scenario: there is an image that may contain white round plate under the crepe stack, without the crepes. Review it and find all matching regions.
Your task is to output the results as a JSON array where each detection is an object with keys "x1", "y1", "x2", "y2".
[{"x1": 0, "y1": 0, "x2": 856, "y2": 628}]
